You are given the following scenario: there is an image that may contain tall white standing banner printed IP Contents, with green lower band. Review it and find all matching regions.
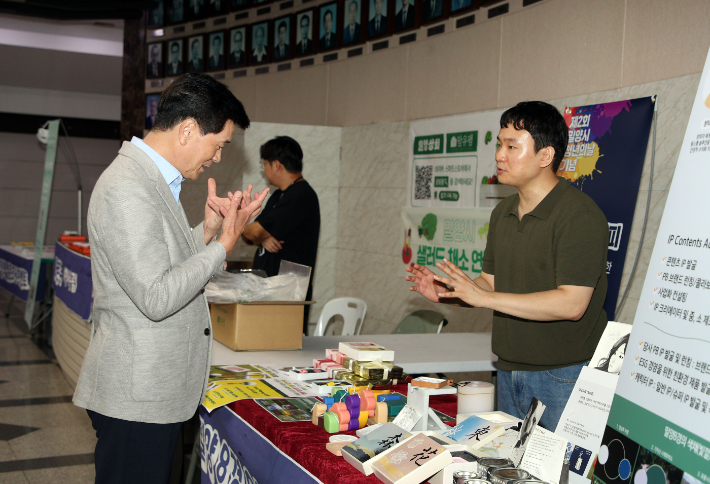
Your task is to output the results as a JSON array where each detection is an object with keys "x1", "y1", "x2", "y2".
[{"x1": 594, "y1": 47, "x2": 710, "y2": 484}]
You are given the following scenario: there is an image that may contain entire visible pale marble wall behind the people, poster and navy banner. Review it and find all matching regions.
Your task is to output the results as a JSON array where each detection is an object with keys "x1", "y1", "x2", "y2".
[{"x1": 181, "y1": 74, "x2": 700, "y2": 334}]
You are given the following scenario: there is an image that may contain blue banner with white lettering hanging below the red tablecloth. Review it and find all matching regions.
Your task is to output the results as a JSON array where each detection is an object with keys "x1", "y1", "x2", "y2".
[{"x1": 200, "y1": 406, "x2": 320, "y2": 484}]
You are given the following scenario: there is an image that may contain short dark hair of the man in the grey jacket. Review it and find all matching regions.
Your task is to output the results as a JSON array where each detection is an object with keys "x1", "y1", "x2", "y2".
[{"x1": 153, "y1": 72, "x2": 251, "y2": 134}]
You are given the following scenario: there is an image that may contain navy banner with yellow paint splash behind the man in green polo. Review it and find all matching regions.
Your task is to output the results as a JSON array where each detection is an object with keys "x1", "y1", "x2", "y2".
[{"x1": 557, "y1": 97, "x2": 654, "y2": 320}]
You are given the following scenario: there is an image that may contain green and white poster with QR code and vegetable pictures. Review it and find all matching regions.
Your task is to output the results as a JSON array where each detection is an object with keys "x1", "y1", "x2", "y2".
[{"x1": 402, "y1": 111, "x2": 515, "y2": 278}]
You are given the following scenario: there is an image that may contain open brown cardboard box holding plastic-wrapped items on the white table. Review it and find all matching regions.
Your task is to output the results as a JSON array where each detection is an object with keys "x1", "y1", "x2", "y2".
[{"x1": 210, "y1": 301, "x2": 313, "y2": 351}]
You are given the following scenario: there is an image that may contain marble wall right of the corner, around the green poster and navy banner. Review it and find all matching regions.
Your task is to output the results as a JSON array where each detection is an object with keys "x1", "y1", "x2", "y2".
[{"x1": 336, "y1": 74, "x2": 700, "y2": 334}]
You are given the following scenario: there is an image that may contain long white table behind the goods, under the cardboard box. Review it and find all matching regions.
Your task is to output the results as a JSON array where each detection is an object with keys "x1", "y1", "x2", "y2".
[{"x1": 212, "y1": 333, "x2": 498, "y2": 374}]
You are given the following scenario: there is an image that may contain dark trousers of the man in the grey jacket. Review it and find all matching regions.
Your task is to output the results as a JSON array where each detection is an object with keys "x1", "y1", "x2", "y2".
[{"x1": 87, "y1": 410, "x2": 182, "y2": 484}]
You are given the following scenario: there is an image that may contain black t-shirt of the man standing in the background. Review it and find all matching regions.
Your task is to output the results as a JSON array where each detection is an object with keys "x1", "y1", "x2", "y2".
[{"x1": 254, "y1": 180, "x2": 320, "y2": 277}]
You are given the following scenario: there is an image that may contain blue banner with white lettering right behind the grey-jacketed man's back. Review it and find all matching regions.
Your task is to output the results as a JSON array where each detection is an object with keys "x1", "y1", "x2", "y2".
[{"x1": 52, "y1": 242, "x2": 93, "y2": 320}]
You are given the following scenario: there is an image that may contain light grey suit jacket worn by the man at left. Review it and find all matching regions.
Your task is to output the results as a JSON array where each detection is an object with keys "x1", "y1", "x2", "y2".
[{"x1": 74, "y1": 142, "x2": 226, "y2": 423}]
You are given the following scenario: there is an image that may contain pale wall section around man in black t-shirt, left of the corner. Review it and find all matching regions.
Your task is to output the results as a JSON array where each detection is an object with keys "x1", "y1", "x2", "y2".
[{"x1": 180, "y1": 123, "x2": 342, "y2": 326}]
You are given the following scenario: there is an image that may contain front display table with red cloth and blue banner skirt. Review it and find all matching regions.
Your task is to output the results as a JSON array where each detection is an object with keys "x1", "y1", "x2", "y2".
[{"x1": 200, "y1": 385, "x2": 456, "y2": 484}]
